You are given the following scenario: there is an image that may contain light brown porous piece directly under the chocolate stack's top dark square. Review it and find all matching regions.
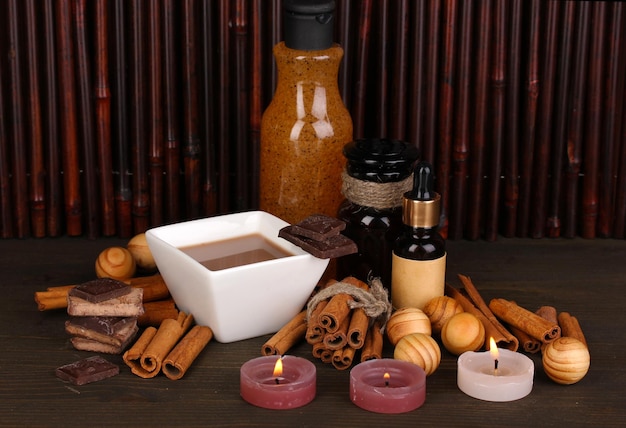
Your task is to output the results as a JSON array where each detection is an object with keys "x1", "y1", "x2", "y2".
[{"x1": 67, "y1": 287, "x2": 144, "y2": 317}]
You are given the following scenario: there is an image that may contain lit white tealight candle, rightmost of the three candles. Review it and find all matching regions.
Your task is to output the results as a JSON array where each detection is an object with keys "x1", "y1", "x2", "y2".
[{"x1": 457, "y1": 340, "x2": 535, "y2": 401}]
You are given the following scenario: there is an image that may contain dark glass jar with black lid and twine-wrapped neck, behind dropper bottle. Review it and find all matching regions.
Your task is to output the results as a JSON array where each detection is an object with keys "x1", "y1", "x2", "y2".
[{"x1": 337, "y1": 139, "x2": 418, "y2": 288}]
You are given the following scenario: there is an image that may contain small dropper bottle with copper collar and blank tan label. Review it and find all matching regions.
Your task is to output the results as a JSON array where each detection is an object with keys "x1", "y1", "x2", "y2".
[{"x1": 391, "y1": 161, "x2": 446, "y2": 309}]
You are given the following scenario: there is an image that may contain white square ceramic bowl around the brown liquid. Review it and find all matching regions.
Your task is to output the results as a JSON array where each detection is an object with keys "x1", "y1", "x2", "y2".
[{"x1": 146, "y1": 211, "x2": 329, "y2": 343}]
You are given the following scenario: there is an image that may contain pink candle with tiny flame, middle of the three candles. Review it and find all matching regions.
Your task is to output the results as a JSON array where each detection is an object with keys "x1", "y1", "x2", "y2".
[{"x1": 350, "y1": 359, "x2": 426, "y2": 413}]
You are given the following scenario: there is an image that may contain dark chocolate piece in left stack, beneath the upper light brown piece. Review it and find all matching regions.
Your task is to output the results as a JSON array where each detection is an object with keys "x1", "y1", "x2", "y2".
[{"x1": 65, "y1": 316, "x2": 137, "y2": 346}]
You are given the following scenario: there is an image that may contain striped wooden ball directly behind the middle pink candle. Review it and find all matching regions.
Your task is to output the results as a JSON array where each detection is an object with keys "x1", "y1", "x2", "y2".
[{"x1": 393, "y1": 333, "x2": 441, "y2": 376}]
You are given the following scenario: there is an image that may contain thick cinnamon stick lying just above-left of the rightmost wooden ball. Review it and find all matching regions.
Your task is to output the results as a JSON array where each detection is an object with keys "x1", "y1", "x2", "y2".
[{"x1": 489, "y1": 299, "x2": 561, "y2": 343}]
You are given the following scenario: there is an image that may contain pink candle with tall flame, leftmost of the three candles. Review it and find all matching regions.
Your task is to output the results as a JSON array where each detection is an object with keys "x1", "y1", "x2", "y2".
[{"x1": 240, "y1": 355, "x2": 316, "y2": 409}]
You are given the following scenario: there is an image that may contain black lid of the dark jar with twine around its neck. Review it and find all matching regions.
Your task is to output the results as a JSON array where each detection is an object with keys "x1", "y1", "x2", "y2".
[{"x1": 343, "y1": 138, "x2": 419, "y2": 183}]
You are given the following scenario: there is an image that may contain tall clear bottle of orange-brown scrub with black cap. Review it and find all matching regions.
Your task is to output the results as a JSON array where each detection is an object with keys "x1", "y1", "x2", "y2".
[{"x1": 259, "y1": 0, "x2": 352, "y2": 223}]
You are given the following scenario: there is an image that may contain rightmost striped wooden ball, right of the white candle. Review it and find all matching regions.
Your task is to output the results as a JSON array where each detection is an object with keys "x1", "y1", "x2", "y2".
[{"x1": 541, "y1": 337, "x2": 591, "y2": 385}]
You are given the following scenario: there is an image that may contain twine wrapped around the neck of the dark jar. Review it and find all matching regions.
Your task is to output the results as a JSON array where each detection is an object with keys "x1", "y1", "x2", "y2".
[{"x1": 341, "y1": 169, "x2": 413, "y2": 210}]
